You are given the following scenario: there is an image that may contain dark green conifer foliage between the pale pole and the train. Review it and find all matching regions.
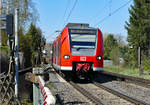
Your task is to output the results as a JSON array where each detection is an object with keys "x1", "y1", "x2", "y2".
[{"x1": 15, "y1": 24, "x2": 45, "y2": 67}]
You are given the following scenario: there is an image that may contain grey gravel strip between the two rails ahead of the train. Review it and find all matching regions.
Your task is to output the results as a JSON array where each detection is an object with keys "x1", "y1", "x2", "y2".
[{"x1": 78, "y1": 83, "x2": 133, "y2": 105}]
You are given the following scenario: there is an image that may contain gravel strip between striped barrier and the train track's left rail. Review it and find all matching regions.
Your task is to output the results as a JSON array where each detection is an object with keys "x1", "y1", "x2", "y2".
[{"x1": 49, "y1": 73, "x2": 93, "y2": 105}]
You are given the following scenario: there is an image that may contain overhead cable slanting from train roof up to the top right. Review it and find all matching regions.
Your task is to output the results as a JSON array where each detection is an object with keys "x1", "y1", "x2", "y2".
[{"x1": 94, "y1": 0, "x2": 132, "y2": 26}]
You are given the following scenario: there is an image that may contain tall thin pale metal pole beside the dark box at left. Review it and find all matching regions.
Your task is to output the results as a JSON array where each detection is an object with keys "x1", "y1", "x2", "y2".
[{"x1": 15, "y1": 8, "x2": 19, "y2": 97}]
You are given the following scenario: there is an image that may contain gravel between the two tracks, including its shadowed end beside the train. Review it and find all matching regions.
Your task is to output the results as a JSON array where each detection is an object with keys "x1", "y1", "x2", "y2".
[{"x1": 95, "y1": 75, "x2": 150, "y2": 103}]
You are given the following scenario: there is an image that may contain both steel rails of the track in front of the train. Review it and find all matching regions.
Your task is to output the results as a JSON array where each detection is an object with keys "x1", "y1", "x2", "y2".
[{"x1": 51, "y1": 67, "x2": 150, "y2": 105}]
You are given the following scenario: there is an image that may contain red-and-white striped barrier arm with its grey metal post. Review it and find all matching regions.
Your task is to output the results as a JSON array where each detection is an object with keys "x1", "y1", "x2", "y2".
[{"x1": 31, "y1": 67, "x2": 56, "y2": 105}]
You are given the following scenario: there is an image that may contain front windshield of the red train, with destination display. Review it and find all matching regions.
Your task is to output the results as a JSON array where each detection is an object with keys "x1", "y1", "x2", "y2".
[{"x1": 70, "y1": 29, "x2": 97, "y2": 56}]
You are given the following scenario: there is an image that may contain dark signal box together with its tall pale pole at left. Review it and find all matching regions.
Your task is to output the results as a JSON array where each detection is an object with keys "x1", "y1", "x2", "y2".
[{"x1": 0, "y1": 9, "x2": 19, "y2": 97}]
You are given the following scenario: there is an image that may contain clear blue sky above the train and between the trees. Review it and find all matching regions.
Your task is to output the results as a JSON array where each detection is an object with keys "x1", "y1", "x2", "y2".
[{"x1": 34, "y1": 0, "x2": 133, "y2": 43}]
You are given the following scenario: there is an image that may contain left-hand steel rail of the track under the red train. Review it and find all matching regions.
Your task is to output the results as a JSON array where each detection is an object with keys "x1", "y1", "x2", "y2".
[{"x1": 69, "y1": 82, "x2": 106, "y2": 105}]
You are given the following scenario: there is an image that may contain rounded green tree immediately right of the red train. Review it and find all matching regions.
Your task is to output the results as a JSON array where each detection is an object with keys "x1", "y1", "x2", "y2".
[{"x1": 104, "y1": 34, "x2": 118, "y2": 59}]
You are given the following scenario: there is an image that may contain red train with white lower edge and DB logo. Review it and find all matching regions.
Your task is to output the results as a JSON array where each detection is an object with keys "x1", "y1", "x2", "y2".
[{"x1": 52, "y1": 23, "x2": 103, "y2": 75}]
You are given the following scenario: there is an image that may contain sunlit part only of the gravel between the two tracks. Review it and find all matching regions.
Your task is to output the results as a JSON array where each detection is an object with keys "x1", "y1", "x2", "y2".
[{"x1": 103, "y1": 81, "x2": 150, "y2": 103}]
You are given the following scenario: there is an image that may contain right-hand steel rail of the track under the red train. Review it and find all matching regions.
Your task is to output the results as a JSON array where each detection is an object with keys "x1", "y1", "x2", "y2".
[{"x1": 92, "y1": 82, "x2": 150, "y2": 105}]
